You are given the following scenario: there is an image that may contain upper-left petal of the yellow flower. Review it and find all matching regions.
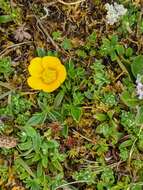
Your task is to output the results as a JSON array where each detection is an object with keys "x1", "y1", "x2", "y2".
[{"x1": 28, "y1": 57, "x2": 43, "y2": 77}]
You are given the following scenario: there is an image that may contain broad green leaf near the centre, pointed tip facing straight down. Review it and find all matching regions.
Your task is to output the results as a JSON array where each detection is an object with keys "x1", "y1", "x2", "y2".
[{"x1": 71, "y1": 106, "x2": 82, "y2": 122}]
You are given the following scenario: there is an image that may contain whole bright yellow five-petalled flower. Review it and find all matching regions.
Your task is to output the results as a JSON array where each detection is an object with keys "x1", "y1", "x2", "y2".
[{"x1": 27, "y1": 56, "x2": 66, "y2": 92}]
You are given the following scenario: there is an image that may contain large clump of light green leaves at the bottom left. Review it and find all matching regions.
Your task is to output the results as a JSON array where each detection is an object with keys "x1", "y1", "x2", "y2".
[{"x1": 15, "y1": 126, "x2": 65, "y2": 190}]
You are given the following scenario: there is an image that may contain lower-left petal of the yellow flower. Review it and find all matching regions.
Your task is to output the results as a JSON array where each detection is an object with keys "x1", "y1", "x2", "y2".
[{"x1": 27, "y1": 76, "x2": 46, "y2": 90}]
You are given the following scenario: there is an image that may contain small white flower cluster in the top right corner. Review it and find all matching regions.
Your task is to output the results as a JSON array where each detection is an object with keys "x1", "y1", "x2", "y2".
[{"x1": 105, "y1": 3, "x2": 127, "y2": 25}]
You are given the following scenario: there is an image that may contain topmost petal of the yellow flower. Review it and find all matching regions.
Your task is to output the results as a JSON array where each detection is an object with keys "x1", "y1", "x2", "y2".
[{"x1": 42, "y1": 56, "x2": 61, "y2": 69}]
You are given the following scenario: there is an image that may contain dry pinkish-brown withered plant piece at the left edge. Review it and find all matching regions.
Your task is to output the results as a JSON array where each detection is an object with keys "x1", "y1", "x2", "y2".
[{"x1": 0, "y1": 136, "x2": 17, "y2": 148}]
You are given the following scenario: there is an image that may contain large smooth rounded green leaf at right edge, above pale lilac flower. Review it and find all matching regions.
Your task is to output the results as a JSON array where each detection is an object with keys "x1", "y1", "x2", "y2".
[{"x1": 131, "y1": 55, "x2": 143, "y2": 77}]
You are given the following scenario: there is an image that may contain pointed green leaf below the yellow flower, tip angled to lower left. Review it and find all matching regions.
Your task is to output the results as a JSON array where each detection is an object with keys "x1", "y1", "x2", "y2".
[{"x1": 26, "y1": 112, "x2": 47, "y2": 126}]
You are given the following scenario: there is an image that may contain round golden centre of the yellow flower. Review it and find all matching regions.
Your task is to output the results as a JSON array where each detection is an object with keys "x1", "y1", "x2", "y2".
[{"x1": 42, "y1": 68, "x2": 57, "y2": 84}]
